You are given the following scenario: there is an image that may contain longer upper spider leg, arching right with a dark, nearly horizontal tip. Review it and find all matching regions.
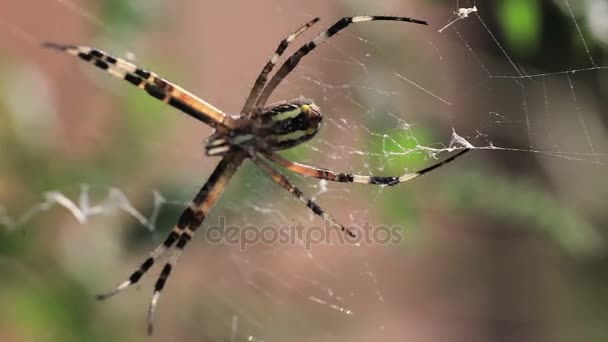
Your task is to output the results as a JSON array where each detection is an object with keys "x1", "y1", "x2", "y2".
[{"x1": 254, "y1": 16, "x2": 427, "y2": 108}]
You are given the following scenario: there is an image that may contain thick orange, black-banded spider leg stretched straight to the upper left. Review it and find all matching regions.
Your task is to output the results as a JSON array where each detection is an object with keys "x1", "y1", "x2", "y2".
[{"x1": 43, "y1": 43, "x2": 235, "y2": 131}]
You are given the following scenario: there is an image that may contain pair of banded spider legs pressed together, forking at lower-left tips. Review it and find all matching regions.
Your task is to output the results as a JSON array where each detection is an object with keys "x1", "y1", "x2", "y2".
[{"x1": 97, "y1": 152, "x2": 245, "y2": 334}]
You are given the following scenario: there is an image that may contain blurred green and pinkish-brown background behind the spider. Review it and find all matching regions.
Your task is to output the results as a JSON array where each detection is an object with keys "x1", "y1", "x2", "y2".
[{"x1": 0, "y1": 0, "x2": 608, "y2": 341}]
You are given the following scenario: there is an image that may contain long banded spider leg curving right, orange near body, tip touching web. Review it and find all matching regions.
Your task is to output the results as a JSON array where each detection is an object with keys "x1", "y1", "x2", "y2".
[{"x1": 264, "y1": 148, "x2": 471, "y2": 186}]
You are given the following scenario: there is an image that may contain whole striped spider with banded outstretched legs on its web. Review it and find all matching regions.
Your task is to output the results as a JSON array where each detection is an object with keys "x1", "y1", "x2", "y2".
[{"x1": 43, "y1": 16, "x2": 469, "y2": 335}]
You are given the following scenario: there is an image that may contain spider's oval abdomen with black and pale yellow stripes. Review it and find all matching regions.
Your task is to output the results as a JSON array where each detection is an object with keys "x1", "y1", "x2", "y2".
[{"x1": 254, "y1": 98, "x2": 323, "y2": 150}]
